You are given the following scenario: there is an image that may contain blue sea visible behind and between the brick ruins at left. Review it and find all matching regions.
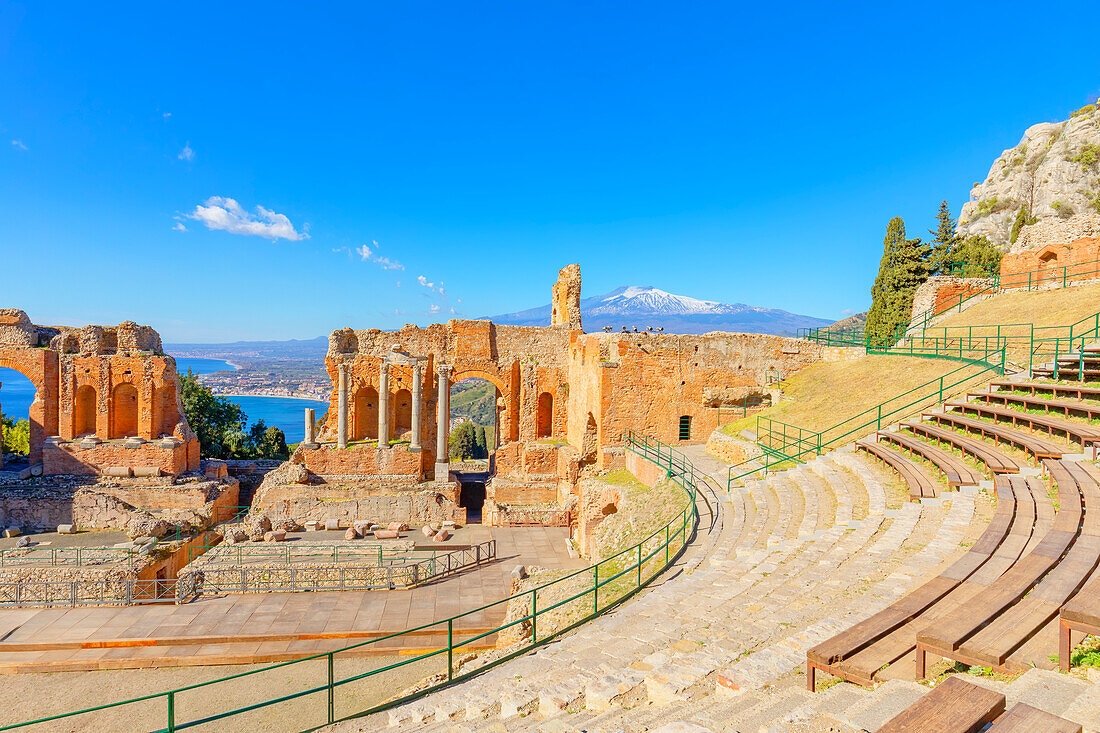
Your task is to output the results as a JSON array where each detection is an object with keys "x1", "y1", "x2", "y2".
[{"x1": 0, "y1": 357, "x2": 329, "y2": 442}]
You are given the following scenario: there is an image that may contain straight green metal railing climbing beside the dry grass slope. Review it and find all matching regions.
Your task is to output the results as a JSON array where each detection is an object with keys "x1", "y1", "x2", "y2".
[{"x1": 726, "y1": 348, "x2": 1004, "y2": 491}]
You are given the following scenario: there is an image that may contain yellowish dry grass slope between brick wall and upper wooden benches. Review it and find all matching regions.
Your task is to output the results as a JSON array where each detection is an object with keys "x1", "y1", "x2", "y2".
[{"x1": 723, "y1": 355, "x2": 972, "y2": 440}]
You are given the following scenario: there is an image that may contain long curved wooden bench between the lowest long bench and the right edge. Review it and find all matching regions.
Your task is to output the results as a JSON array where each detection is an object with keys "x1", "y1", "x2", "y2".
[{"x1": 916, "y1": 461, "x2": 1100, "y2": 679}]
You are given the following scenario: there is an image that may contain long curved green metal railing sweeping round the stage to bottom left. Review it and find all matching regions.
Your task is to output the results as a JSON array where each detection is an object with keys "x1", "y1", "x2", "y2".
[{"x1": 0, "y1": 433, "x2": 702, "y2": 733}]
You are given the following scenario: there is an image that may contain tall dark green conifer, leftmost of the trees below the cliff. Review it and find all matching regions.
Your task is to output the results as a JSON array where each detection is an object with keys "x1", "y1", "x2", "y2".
[{"x1": 866, "y1": 217, "x2": 931, "y2": 346}]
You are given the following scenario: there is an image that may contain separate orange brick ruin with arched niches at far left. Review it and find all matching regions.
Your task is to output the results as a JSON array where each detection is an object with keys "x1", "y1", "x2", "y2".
[{"x1": 0, "y1": 308, "x2": 199, "y2": 475}]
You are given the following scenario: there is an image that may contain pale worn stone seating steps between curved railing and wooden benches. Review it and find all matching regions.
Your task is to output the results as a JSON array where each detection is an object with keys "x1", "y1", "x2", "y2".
[{"x1": 319, "y1": 449, "x2": 1100, "y2": 731}]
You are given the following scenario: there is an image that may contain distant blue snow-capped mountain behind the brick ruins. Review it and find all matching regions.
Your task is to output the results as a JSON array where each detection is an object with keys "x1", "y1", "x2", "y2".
[{"x1": 491, "y1": 285, "x2": 832, "y2": 335}]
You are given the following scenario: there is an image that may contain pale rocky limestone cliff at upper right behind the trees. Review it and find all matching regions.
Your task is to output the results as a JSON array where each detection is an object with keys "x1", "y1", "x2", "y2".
[{"x1": 957, "y1": 105, "x2": 1100, "y2": 252}]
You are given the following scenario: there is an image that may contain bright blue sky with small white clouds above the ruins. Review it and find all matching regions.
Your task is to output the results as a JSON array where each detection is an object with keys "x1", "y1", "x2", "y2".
[{"x1": 0, "y1": 0, "x2": 1100, "y2": 341}]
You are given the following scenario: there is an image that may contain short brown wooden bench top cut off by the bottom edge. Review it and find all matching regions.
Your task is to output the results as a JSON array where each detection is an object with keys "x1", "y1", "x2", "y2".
[{"x1": 879, "y1": 675, "x2": 1007, "y2": 733}]
